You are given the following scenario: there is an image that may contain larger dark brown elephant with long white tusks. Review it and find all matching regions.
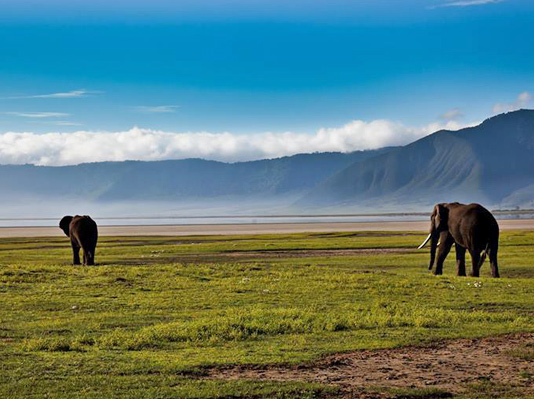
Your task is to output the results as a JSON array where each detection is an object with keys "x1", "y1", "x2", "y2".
[{"x1": 418, "y1": 202, "x2": 499, "y2": 277}]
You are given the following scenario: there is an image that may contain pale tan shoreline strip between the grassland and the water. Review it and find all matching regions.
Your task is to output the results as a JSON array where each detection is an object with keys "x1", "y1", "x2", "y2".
[{"x1": 0, "y1": 219, "x2": 534, "y2": 238}]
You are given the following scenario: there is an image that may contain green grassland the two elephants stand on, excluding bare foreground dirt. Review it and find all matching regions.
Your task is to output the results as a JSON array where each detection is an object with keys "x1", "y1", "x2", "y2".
[{"x1": 0, "y1": 231, "x2": 534, "y2": 398}]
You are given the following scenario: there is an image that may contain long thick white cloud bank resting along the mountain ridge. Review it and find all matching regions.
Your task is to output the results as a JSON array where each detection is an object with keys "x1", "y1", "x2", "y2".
[{"x1": 0, "y1": 120, "x2": 478, "y2": 165}]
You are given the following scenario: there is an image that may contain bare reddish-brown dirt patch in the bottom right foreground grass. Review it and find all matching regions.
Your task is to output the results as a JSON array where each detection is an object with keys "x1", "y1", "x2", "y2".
[{"x1": 208, "y1": 333, "x2": 534, "y2": 397}]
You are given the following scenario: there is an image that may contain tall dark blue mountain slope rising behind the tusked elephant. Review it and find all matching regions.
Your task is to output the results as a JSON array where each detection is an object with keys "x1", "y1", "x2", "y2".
[{"x1": 298, "y1": 110, "x2": 534, "y2": 206}]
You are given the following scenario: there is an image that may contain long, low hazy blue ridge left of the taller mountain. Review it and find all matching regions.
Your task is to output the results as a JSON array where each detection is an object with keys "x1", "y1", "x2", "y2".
[{"x1": 0, "y1": 148, "x2": 390, "y2": 201}]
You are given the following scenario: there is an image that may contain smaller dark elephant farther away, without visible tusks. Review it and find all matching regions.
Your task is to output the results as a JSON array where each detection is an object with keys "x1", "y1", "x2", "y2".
[{"x1": 59, "y1": 215, "x2": 98, "y2": 266}]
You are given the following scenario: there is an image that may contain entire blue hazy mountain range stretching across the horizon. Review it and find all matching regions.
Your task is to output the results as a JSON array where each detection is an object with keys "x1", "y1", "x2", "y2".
[{"x1": 0, "y1": 110, "x2": 534, "y2": 210}]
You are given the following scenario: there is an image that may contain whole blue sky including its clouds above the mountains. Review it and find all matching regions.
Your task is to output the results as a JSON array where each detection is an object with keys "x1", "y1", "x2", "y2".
[{"x1": 0, "y1": 0, "x2": 534, "y2": 165}]
